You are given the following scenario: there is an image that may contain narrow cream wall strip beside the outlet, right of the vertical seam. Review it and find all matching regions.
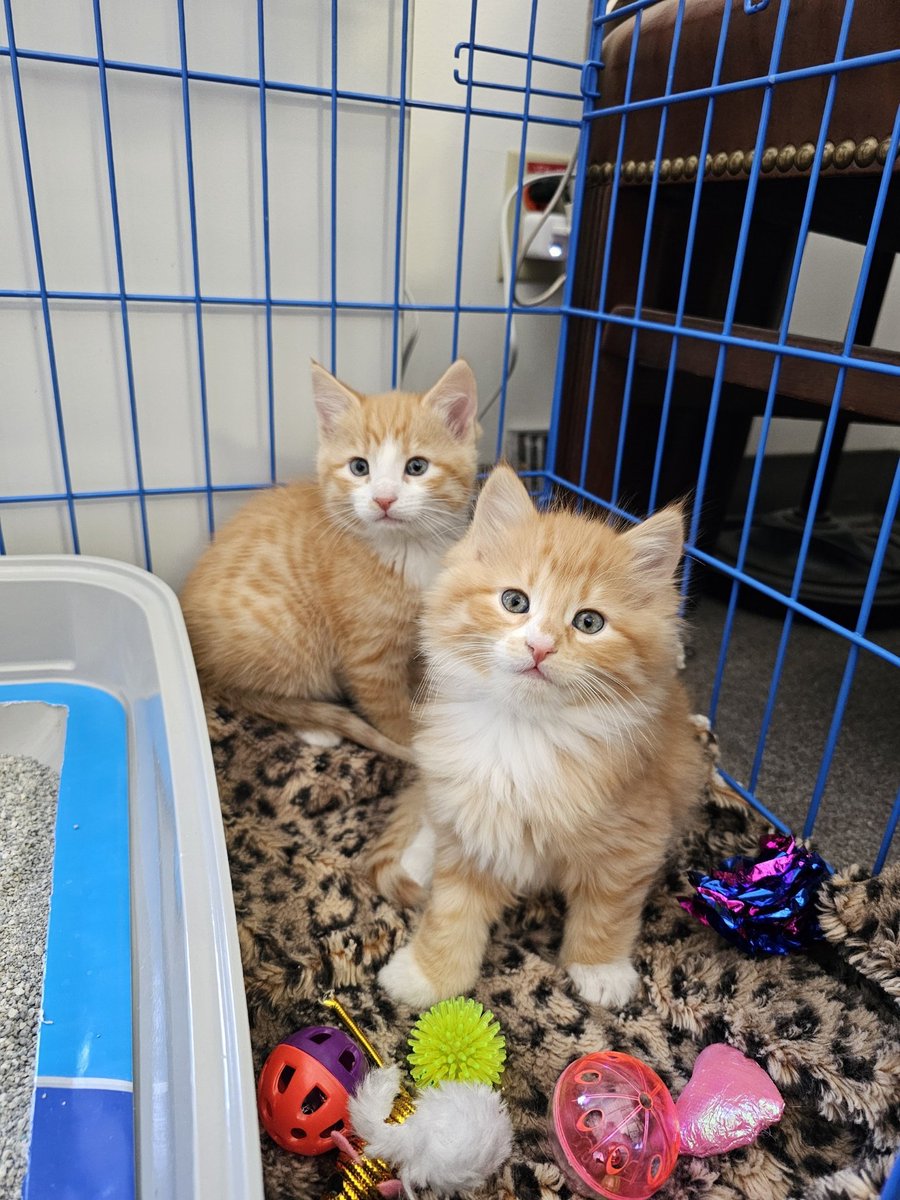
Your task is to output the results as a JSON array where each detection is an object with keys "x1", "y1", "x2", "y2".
[{"x1": 407, "y1": 0, "x2": 588, "y2": 458}]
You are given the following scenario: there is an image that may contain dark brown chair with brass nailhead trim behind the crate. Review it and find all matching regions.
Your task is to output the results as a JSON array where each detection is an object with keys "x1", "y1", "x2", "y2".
[{"x1": 557, "y1": 0, "x2": 900, "y2": 602}]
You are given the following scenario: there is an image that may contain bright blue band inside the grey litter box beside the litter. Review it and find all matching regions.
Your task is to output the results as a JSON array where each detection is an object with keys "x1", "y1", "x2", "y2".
[{"x1": 0, "y1": 683, "x2": 134, "y2": 1200}]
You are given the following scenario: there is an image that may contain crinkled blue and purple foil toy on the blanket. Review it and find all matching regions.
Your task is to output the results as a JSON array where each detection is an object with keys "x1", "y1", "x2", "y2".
[{"x1": 678, "y1": 833, "x2": 832, "y2": 955}]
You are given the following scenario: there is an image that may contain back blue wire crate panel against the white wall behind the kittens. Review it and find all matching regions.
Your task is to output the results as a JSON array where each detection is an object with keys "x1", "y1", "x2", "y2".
[{"x1": 0, "y1": 0, "x2": 588, "y2": 584}]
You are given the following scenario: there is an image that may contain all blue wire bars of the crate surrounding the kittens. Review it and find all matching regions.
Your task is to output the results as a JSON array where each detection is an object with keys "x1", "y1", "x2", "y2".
[{"x1": 0, "y1": 0, "x2": 900, "y2": 870}]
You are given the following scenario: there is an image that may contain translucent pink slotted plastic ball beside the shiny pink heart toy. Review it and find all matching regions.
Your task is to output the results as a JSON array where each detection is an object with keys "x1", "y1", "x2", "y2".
[{"x1": 550, "y1": 1050, "x2": 680, "y2": 1200}]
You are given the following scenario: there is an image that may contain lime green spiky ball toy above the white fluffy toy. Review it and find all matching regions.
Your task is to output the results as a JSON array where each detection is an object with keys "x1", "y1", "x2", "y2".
[{"x1": 407, "y1": 997, "x2": 506, "y2": 1087}]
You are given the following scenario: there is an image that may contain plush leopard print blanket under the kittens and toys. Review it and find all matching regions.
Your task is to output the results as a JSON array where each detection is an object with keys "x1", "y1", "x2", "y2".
[{"x1": 208, "y1": 706, "x2": 900, "y2": 1200}]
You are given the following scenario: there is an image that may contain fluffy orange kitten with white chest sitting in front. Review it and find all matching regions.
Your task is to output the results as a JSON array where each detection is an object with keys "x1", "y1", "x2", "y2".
[{"x1": 373, "y1": 467, "x2": 704, "y2": 1008}]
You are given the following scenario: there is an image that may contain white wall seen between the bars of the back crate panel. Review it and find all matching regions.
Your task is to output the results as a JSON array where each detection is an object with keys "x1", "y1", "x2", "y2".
[{"x1": 0, "y1": 0, "x2": 587, "y2": 584}]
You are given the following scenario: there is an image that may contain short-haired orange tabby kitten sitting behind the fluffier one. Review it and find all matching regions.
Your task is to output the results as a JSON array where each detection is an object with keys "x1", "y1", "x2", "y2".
[{"x1": 181, "y1": 360, "x2": 478, "y2": 758}]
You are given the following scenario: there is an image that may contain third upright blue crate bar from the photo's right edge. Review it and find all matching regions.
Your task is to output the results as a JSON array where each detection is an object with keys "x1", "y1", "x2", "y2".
[{"x1": 750, "y1": 108, "x2": 900, "y2": 787}]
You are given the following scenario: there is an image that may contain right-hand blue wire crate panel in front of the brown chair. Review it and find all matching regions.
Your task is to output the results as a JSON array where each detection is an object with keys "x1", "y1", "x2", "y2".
[{"x1": 547, "y1": 0, "x2": 900, "y2": 870}]
